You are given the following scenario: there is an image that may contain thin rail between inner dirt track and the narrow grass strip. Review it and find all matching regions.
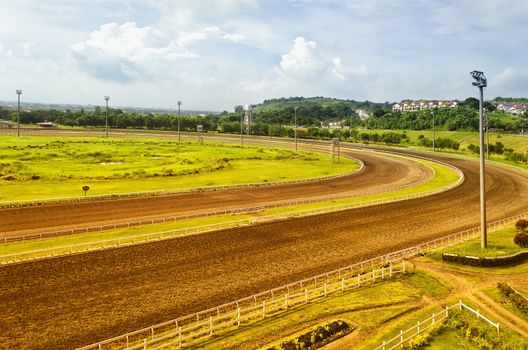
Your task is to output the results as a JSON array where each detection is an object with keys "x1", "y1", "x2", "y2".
[{"x1": 0, "y1": 156, "x2": 438, "y2": 244}]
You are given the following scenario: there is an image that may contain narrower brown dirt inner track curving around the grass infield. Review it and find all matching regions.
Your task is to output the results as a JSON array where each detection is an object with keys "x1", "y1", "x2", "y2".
[{"x1": 0, "y1": 151, "x2": 430, "y2": 237}]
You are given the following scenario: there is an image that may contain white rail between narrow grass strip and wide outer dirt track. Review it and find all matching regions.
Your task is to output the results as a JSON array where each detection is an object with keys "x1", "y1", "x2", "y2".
[{"x1": 0, "y1": 168, "x2": 464, "y2": 264}]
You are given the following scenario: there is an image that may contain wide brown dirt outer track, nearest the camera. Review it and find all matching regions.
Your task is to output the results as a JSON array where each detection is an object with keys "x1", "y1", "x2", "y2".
[{"x1": 0, "y1": 152, "x2": 528, "y2": 349}]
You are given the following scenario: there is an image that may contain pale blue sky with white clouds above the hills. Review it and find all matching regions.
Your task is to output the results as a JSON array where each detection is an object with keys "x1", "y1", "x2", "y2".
[{"x1": 0, "y1": 0, "x2": 528, "y2": 111}]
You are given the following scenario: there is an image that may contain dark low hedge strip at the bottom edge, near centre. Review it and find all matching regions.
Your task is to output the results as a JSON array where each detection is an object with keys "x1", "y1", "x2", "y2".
[{"x1": 268, "y1": 320, "x2": 354, "y2": 350}]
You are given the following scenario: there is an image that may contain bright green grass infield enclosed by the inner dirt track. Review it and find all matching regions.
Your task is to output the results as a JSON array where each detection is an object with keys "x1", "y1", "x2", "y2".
[{"x1": 0, "y1": 137, "x2": 359, "y2": 202}]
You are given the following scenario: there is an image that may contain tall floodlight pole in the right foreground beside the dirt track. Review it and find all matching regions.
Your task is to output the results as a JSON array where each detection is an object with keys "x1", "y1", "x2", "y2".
[{"x1": 471, "y1": 70, "x2": 488, "y2": 249}]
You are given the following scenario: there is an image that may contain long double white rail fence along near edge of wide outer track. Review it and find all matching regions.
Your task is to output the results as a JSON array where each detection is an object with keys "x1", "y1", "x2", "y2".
[{"x1": 71, "y1": 213, "x2": 528, "y2": 350}]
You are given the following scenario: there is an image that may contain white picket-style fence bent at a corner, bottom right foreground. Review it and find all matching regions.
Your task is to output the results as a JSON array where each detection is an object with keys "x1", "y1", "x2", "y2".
[{"x1": 374, "y1": 300, "x2": 500, "y2": 350}]
